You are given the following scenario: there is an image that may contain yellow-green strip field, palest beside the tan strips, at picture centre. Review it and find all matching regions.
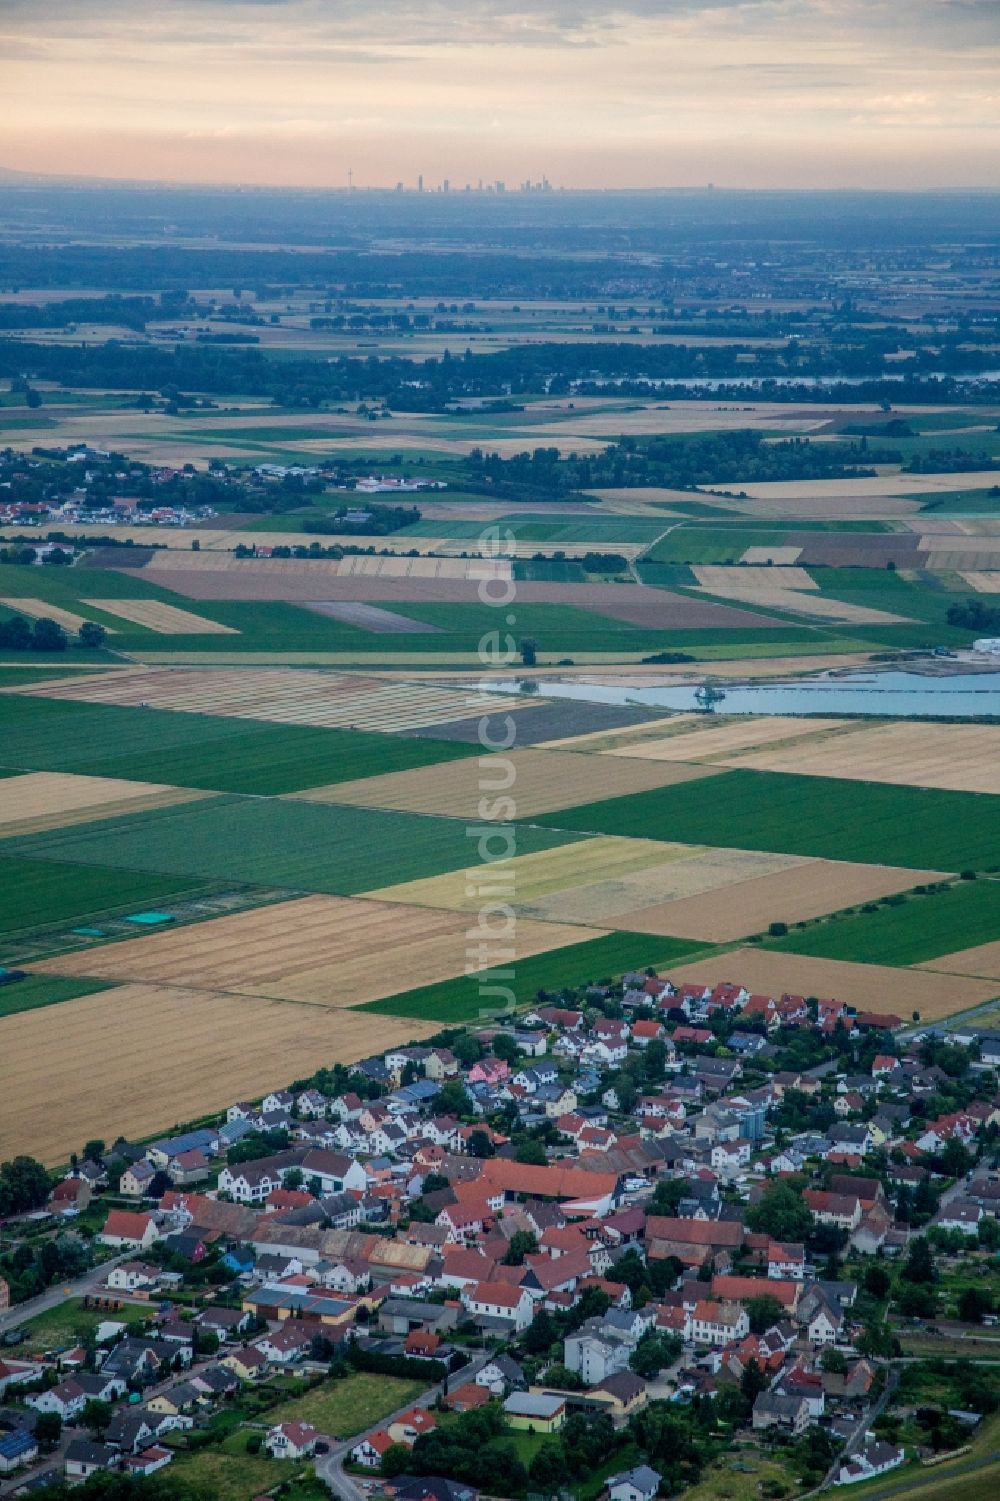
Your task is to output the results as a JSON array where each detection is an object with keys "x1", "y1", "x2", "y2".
[{"x1": 365, "y1": 835, "x2": 678, "y2": 913}]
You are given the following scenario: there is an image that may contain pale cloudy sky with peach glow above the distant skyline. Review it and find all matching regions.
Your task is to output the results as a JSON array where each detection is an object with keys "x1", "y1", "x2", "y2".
[{"x1": 0, "y1": 0, "x2": 1000, "y2": 189}]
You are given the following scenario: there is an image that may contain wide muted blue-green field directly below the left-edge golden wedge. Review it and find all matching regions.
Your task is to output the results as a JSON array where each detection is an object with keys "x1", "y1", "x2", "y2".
[{"x1": 6, "y1": 796, "x2": 580, "y2": 895}]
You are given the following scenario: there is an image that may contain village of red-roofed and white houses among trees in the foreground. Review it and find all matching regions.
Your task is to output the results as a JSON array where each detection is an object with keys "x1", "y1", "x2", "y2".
[{"x1": 0, "y1": 974, "x2": 1000, "y2": 1501}]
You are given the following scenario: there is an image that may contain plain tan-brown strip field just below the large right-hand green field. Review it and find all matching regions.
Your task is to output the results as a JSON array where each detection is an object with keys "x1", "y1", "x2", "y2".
[{"x1": 608, "y1": 860, "x2": 943, "y2": 943}]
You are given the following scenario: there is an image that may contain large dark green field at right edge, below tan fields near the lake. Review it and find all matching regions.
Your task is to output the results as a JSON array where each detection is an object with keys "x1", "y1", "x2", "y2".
[{"x1": 538, "y1": 772, "x2": 1000, "y2": 871}]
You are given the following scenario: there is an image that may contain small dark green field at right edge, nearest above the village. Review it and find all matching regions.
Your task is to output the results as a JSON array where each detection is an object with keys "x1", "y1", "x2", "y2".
[{"x1": 767, "y1": 881, "x2": 1000, "y2": 965}]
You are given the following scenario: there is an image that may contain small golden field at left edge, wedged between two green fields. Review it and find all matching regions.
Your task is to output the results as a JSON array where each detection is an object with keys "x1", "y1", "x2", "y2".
[{"x1": 0, "y1": 772, "x2": 205, "y2": 839}]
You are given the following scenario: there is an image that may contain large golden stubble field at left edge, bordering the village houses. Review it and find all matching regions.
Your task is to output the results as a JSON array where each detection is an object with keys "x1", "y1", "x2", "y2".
[{"x1": 0, "y1": 985, "x2": 438, "y2": 1165}]
